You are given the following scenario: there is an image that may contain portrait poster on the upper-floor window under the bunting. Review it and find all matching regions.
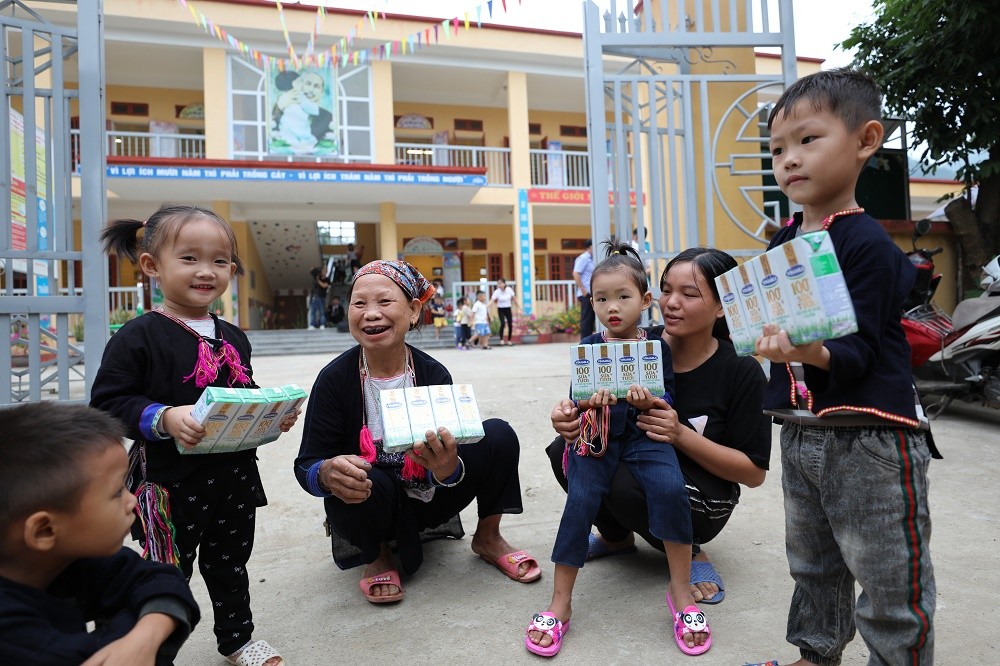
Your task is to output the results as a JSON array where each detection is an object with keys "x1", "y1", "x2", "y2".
[{"x1": 267, "y1": 65, "x2": 340, "y2": 157}]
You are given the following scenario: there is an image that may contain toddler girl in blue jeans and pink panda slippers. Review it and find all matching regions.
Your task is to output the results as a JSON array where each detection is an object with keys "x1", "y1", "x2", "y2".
[{"x1": 524, "y1": 239, "x2": 712, "y2": 657}]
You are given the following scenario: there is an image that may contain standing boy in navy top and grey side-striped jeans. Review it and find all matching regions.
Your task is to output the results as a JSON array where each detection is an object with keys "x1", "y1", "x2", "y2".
[{"x1": 757, "y1": 69, "x2": 935, "y2": 665}]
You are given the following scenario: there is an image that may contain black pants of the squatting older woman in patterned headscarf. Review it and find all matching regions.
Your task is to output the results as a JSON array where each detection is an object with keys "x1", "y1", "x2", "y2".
[{"x1": 325, "y1": 419, "x2": 522, "y2": 574}]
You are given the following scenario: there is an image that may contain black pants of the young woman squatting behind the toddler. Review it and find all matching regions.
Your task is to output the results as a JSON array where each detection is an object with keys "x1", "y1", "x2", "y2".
[{"x1": 545, "y1": 437, "x2": 732, "y2": 553}]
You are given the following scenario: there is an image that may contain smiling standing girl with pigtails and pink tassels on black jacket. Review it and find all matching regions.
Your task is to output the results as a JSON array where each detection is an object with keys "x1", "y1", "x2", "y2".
[{"x1": 91, "y1": 204, "x2": 297, "y2": 666}]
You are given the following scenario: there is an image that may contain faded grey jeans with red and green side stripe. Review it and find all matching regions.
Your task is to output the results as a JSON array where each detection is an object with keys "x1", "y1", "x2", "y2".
[{"x1": 781, "y1": 422, "x2": 936, "y2": 665}]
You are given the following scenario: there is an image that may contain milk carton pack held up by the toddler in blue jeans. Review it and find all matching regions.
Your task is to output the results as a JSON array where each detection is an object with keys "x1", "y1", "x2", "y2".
[{"x1": 570, "y1": 340, "x2": 663, "y2": 400}]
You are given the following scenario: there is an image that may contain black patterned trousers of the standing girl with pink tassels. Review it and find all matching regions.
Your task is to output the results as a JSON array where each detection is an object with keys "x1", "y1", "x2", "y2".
[{"x1": 164, "y1": 460, "x2": 260, "y2": 655}]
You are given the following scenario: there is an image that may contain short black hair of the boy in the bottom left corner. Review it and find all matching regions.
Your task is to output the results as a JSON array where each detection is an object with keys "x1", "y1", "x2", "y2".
[{"x1": 0, "y1": 401, "x2": 124, "y2": 532}]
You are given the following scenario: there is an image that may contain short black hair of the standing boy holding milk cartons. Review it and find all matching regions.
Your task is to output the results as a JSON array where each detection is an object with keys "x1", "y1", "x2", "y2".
[{"x1": 767, "y1": 67, "x2": 882, "y2": 131}]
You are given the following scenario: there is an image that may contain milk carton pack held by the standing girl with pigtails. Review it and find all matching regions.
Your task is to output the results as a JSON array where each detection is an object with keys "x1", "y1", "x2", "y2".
[{"x1": 183, "y1": 384, "x2": 306, "y2": 454}]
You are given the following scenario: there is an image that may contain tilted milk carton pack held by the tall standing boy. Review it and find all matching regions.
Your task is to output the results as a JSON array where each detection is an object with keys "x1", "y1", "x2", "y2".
[{"x1": 715, "y1": 231, "x2": 858, "y2": 356}]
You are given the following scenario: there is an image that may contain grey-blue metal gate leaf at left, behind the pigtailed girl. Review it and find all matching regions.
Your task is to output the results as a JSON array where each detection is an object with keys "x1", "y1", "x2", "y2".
[{"x1": 0, "y1": 0, "x2": 108, "y2": 405}]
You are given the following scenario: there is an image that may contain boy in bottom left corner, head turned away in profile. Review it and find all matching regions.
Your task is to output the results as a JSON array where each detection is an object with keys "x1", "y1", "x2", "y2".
[{"x1": 0, "y1": 402, "x2": 199, "y2": 666}]
